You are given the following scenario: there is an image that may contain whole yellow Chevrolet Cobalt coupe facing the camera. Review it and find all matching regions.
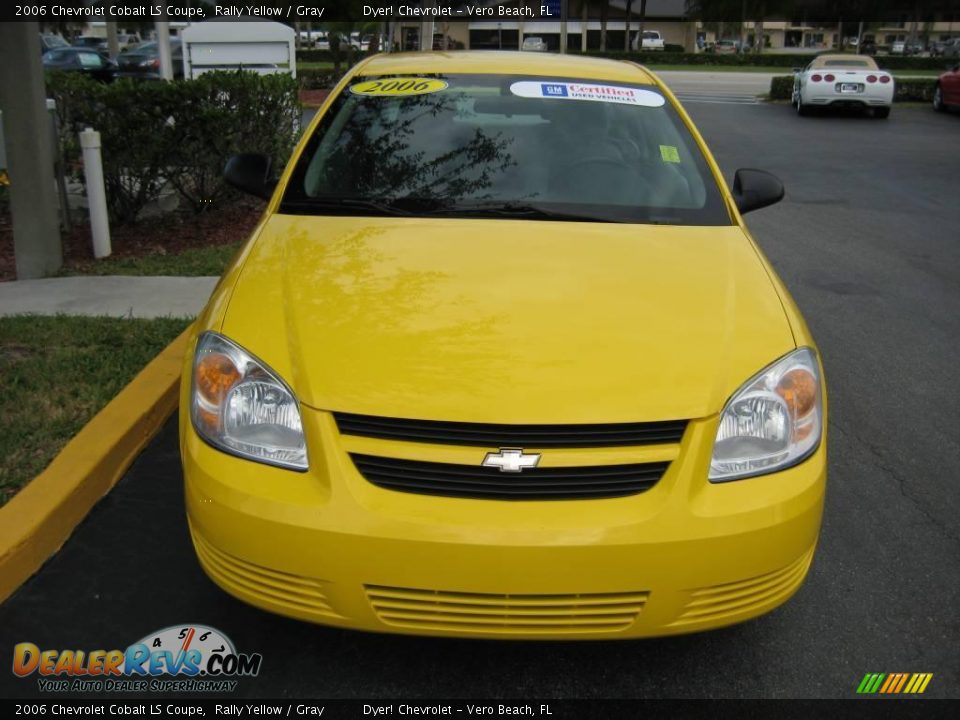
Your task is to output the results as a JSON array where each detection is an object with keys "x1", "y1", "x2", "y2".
[{"x1": 180, "y1": 52, "x2": 827, "y2": 639}]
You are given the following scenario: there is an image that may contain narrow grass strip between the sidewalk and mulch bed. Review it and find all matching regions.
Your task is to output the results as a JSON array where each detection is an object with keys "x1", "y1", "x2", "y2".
[{"x1": 60, "y1": 242, "x2": 243, "y2": 277}]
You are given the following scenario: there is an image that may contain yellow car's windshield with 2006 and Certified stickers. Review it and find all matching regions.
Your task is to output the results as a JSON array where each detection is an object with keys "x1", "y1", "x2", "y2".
[{"x1": 280, "y1": 75, "x2": 731, "y2": 225}]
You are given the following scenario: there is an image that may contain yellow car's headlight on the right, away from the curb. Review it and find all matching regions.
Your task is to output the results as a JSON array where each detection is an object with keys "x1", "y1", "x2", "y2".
[{"x1": 710, "y1": 348, "x2": 823, "y2": 482}]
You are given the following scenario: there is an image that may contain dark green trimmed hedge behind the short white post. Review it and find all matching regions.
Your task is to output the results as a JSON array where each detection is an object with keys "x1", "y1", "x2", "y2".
[{"x1": 47, "y1": 72, "x2": 301, "y2": 223}]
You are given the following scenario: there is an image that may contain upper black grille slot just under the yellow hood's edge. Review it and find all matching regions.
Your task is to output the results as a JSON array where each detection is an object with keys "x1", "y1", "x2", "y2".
[{"x1": 333, "y1": 413, "x2": 687, "y2": 448}]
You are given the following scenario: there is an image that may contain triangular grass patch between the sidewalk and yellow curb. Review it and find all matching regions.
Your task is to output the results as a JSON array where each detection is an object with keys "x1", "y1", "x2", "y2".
[{"x1": 0, "y1": 315, "x2": 191, "y2": 506}]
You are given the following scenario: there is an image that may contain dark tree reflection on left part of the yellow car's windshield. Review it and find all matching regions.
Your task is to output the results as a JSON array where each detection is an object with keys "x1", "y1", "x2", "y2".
[{"x1": 324, "y1": 93, "x2": 516, "y2": 206}]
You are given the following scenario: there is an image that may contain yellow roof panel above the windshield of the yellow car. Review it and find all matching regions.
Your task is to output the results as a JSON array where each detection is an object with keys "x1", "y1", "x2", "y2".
[{"x1": 356, "y1": 50, "x2": 655, "y2": 85}]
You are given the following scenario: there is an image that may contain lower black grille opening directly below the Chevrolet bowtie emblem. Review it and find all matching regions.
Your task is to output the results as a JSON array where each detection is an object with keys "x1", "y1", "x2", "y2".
[{"x1": 350, "y1": 453, "x2": 670, "y2": 500}]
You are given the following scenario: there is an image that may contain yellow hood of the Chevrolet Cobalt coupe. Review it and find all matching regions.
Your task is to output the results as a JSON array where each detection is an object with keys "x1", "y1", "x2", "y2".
[{"x1": 222, "y1": 215, "x2": 794, "y2": 423}]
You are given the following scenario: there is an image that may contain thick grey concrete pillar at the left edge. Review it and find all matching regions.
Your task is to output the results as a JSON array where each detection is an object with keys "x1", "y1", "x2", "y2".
[{"x1": 0, "y1": 22, "x2": 63, "y2": 280}]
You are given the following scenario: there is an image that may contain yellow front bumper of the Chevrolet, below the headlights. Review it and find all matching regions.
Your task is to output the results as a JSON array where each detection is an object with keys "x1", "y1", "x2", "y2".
[{"x1": 180, "y1": 403, "x2": 826, "y2": 639}]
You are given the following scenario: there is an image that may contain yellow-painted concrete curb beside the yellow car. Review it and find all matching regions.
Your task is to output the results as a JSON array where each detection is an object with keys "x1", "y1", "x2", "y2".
[{"x1": 0, "y1": 328, "x2": 190, "y2": 602}]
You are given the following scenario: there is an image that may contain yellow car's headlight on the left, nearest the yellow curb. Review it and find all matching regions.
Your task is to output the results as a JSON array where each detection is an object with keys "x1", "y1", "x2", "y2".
[{"x1": 190, "y1": 332, "x2": 307, "y2": 470}]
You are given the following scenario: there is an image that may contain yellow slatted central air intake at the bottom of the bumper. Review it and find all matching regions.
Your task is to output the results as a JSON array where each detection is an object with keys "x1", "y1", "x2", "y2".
[{"x1": 366, "y1": 585, "x2": 649, "y2": 635}]
